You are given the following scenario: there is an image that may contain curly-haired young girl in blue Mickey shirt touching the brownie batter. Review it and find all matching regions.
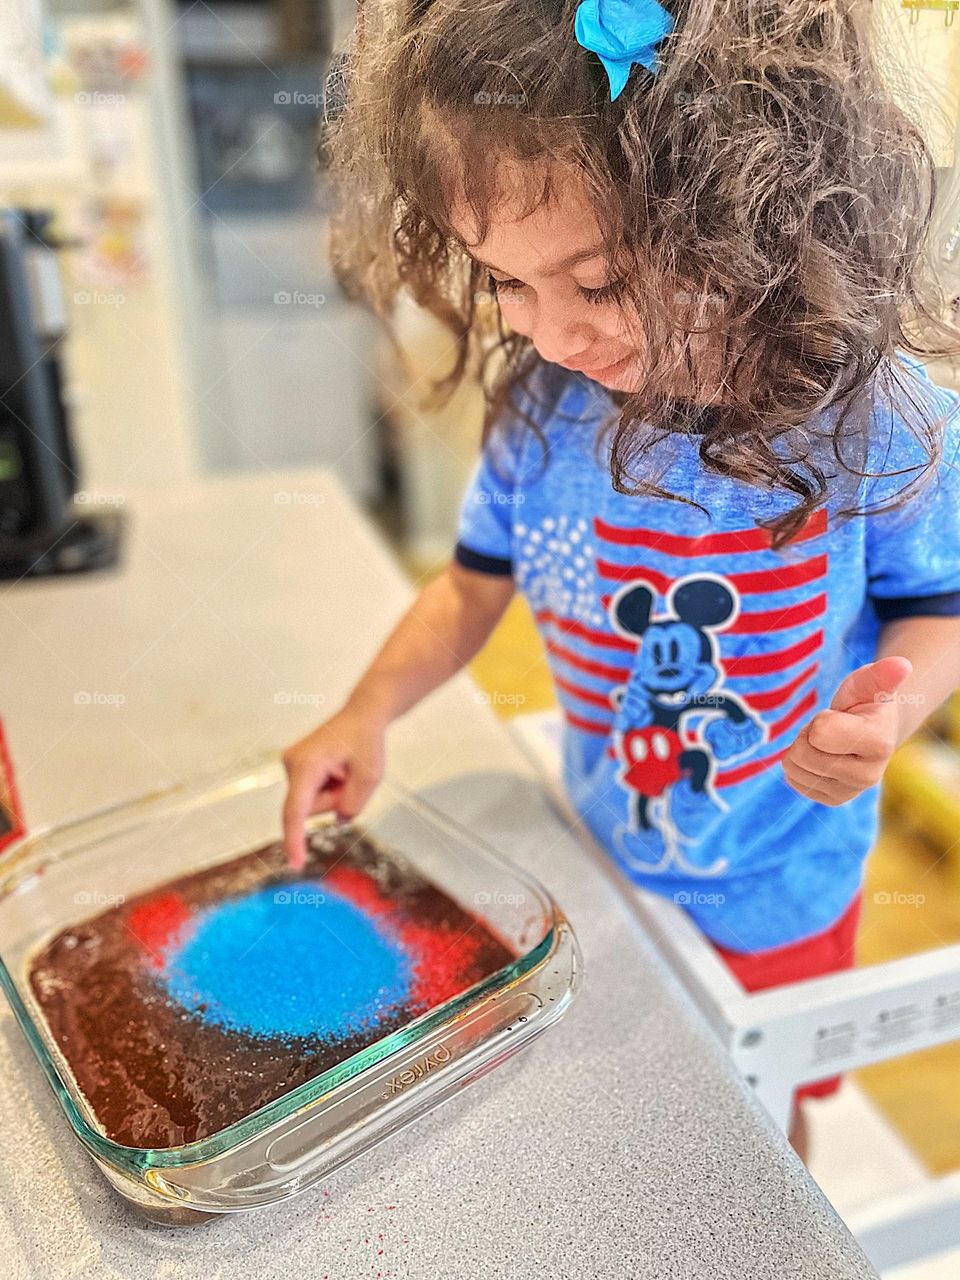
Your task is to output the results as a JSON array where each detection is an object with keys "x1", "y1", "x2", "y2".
[{"x1": 284, "y1": 0, "x2": 960, "y2": 1147}]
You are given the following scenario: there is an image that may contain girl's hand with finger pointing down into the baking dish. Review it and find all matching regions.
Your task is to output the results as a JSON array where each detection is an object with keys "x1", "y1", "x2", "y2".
[{"x1": 283, "y1": 708, "x2": 384, "y2": 870}]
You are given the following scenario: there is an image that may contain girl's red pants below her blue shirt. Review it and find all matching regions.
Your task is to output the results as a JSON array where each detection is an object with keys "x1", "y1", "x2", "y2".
[{"x1": 713, "y1": 893, "x2": 860, "y2": 1101}]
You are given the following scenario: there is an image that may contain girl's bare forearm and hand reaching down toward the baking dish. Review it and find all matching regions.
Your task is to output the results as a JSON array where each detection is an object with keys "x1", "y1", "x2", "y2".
[{"x1": 283, "y1": 562, "x2": 513, "y2": 867}]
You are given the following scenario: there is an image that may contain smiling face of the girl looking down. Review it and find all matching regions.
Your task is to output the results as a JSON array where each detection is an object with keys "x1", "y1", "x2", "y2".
[{"x1": 452, "y1": 170, "x2": 639, "y2": 390}]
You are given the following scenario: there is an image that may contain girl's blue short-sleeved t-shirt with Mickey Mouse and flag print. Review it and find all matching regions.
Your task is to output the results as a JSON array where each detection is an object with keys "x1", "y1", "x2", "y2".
[{"x1": 456, "y1": 366, "x2": 960, "y2": 951}]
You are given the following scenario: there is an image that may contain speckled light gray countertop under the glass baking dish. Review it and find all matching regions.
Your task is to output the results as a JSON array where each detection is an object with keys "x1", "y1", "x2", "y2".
[{"x1": 0, "y1": 472, "x2": 876, "y2": 1280}]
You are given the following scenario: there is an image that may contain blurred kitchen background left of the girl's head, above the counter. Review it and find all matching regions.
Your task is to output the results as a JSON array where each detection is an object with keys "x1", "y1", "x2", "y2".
[{"x1": 0, "y1": 0, "x2": 479, "y2": 561}]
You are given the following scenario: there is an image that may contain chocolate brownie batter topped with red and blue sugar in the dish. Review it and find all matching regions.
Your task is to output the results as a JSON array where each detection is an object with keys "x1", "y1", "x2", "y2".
[{"x1": 29, "y1": 829, "x2": 515, "y2": 1147}]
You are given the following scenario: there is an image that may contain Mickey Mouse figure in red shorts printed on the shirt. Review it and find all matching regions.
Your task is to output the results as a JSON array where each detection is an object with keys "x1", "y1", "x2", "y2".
[{"x1": 609, "y1": 573, "x2": 767, "y2": 873}]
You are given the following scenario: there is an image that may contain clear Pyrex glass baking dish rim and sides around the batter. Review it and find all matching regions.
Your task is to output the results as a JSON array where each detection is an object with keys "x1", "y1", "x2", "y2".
[{"x1": 0, "y1": 760, "x2": 581, "y2": 1224}]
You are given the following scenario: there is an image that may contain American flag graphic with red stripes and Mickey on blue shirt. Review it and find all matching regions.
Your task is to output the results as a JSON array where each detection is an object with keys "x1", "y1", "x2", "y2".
[{"x1": 515, "y1": 508, "x2": 828, "y2": 865}]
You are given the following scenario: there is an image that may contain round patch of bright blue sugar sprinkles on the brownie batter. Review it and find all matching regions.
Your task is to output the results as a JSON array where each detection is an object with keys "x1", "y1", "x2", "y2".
[{"x1": 163, "y1": 881, "x2": 411, "y2": 1039}]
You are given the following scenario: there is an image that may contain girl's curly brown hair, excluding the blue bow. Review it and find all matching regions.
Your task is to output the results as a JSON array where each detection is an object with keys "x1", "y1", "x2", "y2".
[{"x1": 324, "y1": 0, "x2": 959, "y2": 545}]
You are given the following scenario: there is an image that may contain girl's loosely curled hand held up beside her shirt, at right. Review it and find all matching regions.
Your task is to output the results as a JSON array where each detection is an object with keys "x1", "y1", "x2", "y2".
[{"x1": 783, "y1": 657, "x2": 913, "y2": 805}]
